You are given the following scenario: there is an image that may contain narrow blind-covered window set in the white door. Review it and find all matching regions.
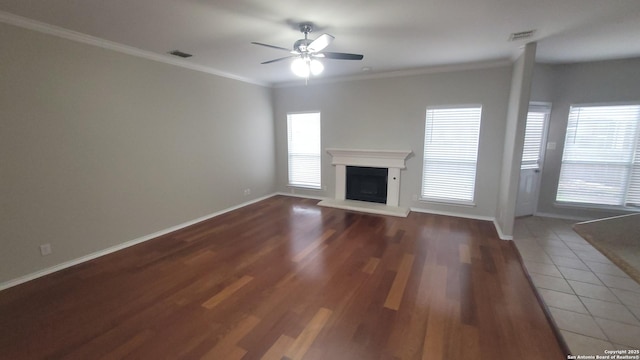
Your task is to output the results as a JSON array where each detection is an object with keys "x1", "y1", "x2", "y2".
[{"x1": 520, "y1": 105, "x2": 551, "y2": 170}]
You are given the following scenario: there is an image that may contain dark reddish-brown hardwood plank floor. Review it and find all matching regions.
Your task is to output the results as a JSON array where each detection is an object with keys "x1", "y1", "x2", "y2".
[{"x1": 0, "y1": 196, "x2": 566, "y2": 360}]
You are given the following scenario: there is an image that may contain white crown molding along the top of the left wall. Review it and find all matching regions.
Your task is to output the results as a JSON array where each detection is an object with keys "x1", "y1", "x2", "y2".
[{"x1": 0, "y1": 11, "x2": 271, "y2": 87}]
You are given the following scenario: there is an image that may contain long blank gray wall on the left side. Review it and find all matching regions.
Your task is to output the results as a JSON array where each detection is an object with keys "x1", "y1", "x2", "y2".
[{"x1": 0, "y1": 23, "x2": 275, "y2": 284}]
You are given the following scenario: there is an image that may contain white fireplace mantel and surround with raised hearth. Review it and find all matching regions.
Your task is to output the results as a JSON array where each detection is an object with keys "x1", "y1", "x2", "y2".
[{"x1": 319, "y1": 149, "x2": 412, "y2": 216}]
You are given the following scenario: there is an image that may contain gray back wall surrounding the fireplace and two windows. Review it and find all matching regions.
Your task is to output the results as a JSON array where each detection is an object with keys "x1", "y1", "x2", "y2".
[{"x1": 274, "y1": 66, "x2": 512, "y2": 219}]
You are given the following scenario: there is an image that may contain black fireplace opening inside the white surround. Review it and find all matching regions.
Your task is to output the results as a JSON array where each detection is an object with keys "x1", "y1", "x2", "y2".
[{"x1": 346, "y1": 166, "x2": 389, "y2": 204}]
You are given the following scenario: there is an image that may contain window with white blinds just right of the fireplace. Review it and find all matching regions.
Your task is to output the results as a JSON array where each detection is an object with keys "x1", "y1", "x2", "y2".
[{"x1": 422, "y1": 106, "x2": 482, "y2": 204}]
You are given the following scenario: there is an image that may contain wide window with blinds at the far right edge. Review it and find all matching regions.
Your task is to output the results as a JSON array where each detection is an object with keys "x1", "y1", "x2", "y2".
[{"x1": 556, "y1": 105, "x2": 640, "y2": 207}]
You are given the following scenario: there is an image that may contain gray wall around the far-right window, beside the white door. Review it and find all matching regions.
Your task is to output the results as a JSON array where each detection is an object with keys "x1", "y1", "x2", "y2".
[{"x1": 531, "y1": 58, "x2": 640, "y2": 219}]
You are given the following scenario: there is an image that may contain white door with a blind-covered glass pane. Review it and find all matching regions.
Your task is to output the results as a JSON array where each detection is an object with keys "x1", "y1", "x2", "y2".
[{"x1": 516, "y1": 104, "x2": 551, "y2": 216}]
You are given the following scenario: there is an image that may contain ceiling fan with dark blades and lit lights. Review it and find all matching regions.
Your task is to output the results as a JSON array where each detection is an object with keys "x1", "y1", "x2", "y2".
[{"x1": 251, "y1": 23, "x2": 364, "y2": 78}]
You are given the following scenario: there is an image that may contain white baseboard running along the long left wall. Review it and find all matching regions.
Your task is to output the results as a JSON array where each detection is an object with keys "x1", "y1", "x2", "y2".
[{"x1": 0, "y1": 193, "x2": 276, "y2": 291}]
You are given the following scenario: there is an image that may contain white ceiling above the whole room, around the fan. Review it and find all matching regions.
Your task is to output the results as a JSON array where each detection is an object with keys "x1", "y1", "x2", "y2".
[{"x1": 0, "y1": 0, "x2": 640, "y2": 84}]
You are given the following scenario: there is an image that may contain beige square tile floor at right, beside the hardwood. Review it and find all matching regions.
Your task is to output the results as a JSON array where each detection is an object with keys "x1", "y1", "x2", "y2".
[{"x1": 514, "y1": 216, "x2": 640, "y2": 355}]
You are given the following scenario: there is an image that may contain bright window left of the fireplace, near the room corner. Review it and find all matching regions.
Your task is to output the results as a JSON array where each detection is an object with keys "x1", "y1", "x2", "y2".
[{"x1": 287, "y1": 112, "x2": 320, "y2": 189}]
